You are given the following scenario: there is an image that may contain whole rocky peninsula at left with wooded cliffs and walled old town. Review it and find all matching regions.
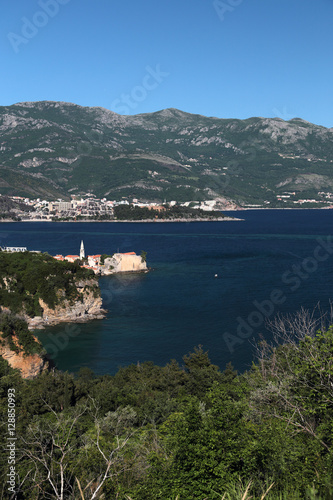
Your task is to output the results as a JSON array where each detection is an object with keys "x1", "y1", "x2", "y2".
[{"x1": 0, "y1": 241, "x2": 148, "y2": 378}]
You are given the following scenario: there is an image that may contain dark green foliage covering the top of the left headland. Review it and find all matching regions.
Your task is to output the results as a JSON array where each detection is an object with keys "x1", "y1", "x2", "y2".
[{"x1": 0, "y1": 252, "x2": 97, "y2": 317}]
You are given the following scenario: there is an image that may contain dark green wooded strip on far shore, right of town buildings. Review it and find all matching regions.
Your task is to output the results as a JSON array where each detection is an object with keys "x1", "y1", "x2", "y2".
[{"x1": 114, "y1": 205, "x2": 224, "y2": 220}]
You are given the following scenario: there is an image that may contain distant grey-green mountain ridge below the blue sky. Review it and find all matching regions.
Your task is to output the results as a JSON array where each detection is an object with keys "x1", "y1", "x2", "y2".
[{"x1": 0, "y1": 101, "x2": 333, "y2": 206}]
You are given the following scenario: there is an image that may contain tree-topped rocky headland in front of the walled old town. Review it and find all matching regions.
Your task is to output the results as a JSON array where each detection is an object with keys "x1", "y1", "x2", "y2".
[{"x1": 0, "y1": 249, "x2": 106, "y2": 328}]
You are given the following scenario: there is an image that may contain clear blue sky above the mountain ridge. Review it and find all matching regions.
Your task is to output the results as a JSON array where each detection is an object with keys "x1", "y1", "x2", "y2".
[{"x1": 0, "y1": 0, "x2": 333, "y2": 127}]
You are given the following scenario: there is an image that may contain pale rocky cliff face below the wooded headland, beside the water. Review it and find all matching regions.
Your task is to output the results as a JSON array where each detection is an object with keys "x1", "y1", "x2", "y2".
[{"x1": 26, "y1": 280, "x2": 106, "y2": 329}]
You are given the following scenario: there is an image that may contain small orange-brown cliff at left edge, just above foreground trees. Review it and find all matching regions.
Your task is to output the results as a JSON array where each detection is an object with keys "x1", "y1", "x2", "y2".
[{"x1": 0, "y1": 333, "x2": 49, "y2": 379}]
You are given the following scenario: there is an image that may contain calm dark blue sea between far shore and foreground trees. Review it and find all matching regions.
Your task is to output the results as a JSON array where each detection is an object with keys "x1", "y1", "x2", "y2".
[{"x1": 0, "y1": 210, "x2": 333, "y2": 374}]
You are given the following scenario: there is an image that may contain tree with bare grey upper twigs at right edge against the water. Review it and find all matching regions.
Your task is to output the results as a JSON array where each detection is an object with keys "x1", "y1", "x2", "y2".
[{"x1": 248, "y1": 309, "x2": 333, "y2": 482}]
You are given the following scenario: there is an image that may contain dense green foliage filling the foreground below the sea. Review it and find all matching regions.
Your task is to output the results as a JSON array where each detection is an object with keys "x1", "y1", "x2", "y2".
[{"x1": 0, "y1": 328, "x2": 333, "y2": 500}]
